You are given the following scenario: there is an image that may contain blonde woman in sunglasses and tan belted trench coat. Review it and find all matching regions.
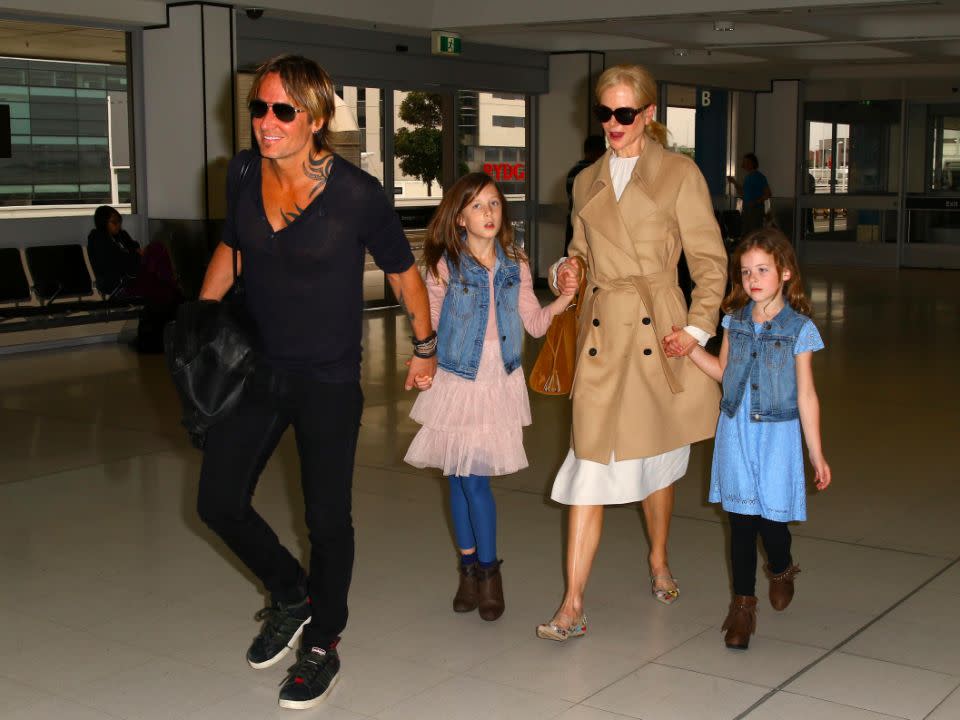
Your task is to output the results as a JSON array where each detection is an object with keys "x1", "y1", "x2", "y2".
[{"x1": 537, "y1": 65, "x2": 727, "y2": 641}]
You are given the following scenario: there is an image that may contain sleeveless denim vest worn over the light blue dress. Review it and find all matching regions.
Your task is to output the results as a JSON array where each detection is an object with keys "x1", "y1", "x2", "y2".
[{"x1": 720, "y1": 302, "x2": 807, "y2": 422}]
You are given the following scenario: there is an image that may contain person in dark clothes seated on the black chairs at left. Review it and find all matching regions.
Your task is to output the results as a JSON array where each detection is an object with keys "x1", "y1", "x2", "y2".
[{"x1": 87, "y1": 205, "x2": 183, "y2": 352}]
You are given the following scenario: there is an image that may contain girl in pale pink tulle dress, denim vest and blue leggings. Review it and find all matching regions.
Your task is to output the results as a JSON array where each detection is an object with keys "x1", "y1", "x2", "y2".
[{"x1": 405, "y1": 173, "x2": 575, "y2": 620}]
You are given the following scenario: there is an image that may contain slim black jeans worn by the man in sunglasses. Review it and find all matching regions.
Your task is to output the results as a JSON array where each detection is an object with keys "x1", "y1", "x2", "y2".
[{"x1": 197, "y1": 371, "x2": 363, "y2": 648}]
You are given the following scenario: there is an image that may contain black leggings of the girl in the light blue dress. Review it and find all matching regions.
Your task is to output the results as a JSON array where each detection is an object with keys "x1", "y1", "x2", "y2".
[{"x1": 727, "y1": 513, "x2": 793, "y2": 595}]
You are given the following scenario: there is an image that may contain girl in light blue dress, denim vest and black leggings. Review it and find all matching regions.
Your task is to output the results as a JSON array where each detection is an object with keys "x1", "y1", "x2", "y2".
[{"x1": 666, "y1": 228, "x2": 830, "y2": 649}]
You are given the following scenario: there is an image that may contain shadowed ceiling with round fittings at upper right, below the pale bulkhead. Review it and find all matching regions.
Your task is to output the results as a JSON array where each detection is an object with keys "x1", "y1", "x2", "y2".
[{"x1": 454, "y1": 0, "x2": 960, "y2": 70}]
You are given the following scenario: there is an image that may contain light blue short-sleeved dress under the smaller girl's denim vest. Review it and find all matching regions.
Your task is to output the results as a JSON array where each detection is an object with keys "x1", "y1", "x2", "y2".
[{"x1": 709, "y1": 315, "x2": 823, "y2": 522}]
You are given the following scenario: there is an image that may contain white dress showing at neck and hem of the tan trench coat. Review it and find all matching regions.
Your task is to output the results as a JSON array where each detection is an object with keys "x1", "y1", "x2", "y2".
[{"x1": 550, "y1": 155, "x2": 690, "y2": 505}]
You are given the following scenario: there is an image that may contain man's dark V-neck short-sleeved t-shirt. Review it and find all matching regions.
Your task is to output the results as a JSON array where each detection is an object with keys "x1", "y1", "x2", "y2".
[{"x1": 223, "y1": 150, "x2": 413, "y2": 382}]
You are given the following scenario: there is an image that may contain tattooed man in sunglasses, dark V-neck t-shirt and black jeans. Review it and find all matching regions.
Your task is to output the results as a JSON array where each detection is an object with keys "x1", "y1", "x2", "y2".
[{"x1": 197, "y1": 55, "x2": 436, "y2": 709}]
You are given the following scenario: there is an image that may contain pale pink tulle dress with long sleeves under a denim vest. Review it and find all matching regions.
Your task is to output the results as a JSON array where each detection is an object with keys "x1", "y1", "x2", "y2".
[{"x1": 404, "y1": 262, "x2": 555, "y2": 476}]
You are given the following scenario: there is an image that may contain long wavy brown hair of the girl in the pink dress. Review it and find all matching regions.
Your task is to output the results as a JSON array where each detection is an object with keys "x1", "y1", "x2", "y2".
[{"x1": 423, "y1": 172, "x2": 527, "y2": 278}]
